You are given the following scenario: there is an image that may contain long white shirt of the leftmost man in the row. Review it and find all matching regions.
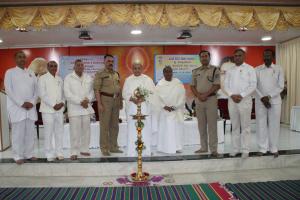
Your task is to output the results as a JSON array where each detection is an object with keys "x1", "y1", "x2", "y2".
[{"x1": 4, "y1": 67, "x2": 37, "y2": 123}]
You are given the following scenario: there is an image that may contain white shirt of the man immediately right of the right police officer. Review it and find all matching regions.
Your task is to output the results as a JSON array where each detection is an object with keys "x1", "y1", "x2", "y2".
[{"x1": 224, "y1": 63, "x2": 256, "y2": 97}]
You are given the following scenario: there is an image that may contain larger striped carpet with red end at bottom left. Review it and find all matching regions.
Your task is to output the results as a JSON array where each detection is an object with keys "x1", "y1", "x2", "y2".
[{"x1": 0, "y1": 183, "x2": 233, "y2": 200}]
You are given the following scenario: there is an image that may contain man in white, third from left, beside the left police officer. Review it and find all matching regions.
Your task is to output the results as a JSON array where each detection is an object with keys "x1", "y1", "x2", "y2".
[{"x1": 64, "y1": 59, "x2": 94, "y2": 160}]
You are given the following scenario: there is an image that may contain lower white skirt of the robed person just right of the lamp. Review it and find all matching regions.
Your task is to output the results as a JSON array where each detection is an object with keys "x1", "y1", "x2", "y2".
[{"x1": 157, "y1": 111, "x2": 183, "y2": 153}]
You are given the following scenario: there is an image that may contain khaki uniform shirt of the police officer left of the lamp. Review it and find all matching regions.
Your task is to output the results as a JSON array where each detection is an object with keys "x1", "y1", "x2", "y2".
[{"x1": 94, "y1": 68, "x2": 121, "y2": 94}]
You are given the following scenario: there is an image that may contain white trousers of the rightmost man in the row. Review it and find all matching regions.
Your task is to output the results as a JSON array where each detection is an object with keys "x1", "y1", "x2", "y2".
[{"x1": 255, "y1": 102, "x2": 281, "y2": 153}]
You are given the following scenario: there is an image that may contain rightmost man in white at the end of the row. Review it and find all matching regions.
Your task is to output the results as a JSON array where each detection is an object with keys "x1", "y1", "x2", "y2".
[{"x1": 255, "y1": 49, "x2": 284, "y2": 157}]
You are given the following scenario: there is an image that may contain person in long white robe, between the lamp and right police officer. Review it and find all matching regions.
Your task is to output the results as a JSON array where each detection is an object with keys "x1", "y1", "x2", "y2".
[{"x1": 156, "y1": 66, "x2": 185, "y2": 154}]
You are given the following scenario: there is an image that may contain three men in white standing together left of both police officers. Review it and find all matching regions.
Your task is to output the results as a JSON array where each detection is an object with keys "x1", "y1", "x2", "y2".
[{"x1": 4, "y1": 51, "x2": 94, "y2": 164}]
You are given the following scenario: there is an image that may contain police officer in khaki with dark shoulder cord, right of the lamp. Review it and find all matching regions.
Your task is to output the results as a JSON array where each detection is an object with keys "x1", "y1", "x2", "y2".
[{"x1": 191, "y1": 51, "x2": 220, "y2": 157}]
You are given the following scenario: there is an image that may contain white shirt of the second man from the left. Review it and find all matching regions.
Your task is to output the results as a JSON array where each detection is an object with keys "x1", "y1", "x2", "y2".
[{"x1": 38, "y1": 72, "x2": 64, "y2": 113}]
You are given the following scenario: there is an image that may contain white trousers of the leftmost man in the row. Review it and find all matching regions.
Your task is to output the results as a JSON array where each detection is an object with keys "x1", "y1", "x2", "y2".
[{"x1": 12, "y1": 119, "x2": 36, "y2": 161}]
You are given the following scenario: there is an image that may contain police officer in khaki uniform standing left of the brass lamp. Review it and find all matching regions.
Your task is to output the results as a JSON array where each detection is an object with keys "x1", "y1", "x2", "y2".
[{"x1": 94, "y1": 55, "x2": 123, "y2": 156}]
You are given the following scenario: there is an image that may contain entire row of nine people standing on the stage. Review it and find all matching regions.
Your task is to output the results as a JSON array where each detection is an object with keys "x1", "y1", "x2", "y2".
[{"x1": 4, "y1": 49, "x2": 284, "y2": 164}]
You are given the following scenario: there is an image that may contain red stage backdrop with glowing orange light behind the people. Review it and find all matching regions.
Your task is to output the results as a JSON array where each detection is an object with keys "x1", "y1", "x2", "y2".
[{"x1": 0, "y1": 45, "x2": 275, "y2": 100}]
